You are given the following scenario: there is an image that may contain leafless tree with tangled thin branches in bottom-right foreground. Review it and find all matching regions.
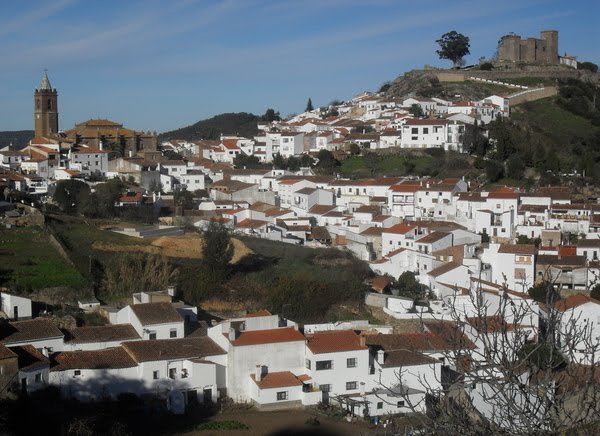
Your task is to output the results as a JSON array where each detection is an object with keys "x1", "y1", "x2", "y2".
[{"x1": 382, "y1": 280, "x2": 600, "y2": 435}]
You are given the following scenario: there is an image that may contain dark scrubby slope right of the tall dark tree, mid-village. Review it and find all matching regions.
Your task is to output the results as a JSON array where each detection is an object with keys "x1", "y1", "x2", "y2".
[{"x1": 230, "y1": 238, "x2": 370, "y2": 322}]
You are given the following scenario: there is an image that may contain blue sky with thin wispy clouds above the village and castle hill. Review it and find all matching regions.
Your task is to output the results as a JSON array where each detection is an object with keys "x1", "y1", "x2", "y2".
[{"x1": 0, "y1": 0, "x2": 600, "y2": 132}]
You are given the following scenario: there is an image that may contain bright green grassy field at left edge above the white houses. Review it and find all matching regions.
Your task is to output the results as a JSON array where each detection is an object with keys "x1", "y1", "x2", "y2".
[{"x1": 0, "y1": 227, "x2": 87, "y2": 290}]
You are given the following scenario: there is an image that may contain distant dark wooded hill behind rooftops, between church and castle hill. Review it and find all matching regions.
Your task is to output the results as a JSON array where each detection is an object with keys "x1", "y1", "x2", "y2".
[{"x1": 158, "y1": 112, "x2": 260, "y2": 141}]
